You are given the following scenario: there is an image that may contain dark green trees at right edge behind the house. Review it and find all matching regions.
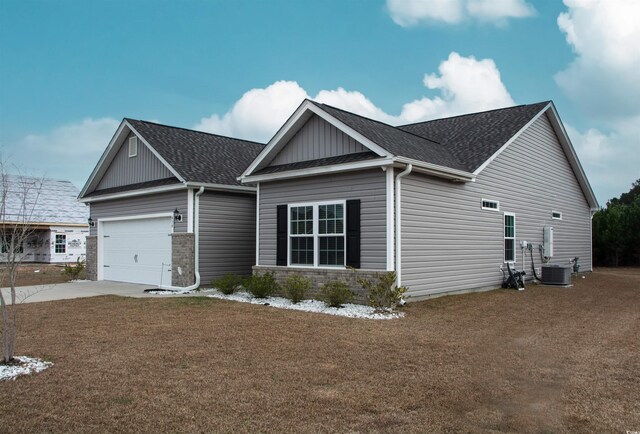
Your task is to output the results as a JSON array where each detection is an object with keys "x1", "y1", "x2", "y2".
[{"x1": 593, "y1": 179, "x2": 640, "y2": 266}]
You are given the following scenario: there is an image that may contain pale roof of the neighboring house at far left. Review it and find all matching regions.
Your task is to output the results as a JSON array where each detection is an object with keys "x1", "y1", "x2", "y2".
[{"x1": 2, "y1": 175, "x2": 89, "y2": 226}]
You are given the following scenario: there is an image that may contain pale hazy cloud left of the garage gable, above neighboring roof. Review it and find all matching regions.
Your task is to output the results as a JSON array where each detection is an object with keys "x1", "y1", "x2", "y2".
[{"x1": 2, "y1": 118, "x2": 120, "y2": 188}]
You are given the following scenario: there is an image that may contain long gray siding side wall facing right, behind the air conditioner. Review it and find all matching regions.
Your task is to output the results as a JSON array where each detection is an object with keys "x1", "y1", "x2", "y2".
[{"x1": 402, "y1": 114, "x2": 591, "y2": 297}]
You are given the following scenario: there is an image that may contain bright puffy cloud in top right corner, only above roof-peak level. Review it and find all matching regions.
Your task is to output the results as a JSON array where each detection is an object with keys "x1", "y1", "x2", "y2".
[{"x1": 555, "y1": 0, "x2": 640, "y2": 120}]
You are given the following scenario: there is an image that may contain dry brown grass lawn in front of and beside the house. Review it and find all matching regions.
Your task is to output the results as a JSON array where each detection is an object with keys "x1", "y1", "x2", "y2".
[{"x1": 0, "y1": 269, "x2": 640, "y2": 432}]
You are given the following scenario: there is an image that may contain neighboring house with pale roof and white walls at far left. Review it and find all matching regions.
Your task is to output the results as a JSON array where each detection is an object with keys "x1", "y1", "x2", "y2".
[{"x1": 0, "y1": 175, "x2": 89, "y2": 263}]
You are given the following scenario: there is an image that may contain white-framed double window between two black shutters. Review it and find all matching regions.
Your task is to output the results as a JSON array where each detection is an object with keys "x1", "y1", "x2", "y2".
[{"x1": 289, "y1": 202, "x2": 345, "y2": 267}]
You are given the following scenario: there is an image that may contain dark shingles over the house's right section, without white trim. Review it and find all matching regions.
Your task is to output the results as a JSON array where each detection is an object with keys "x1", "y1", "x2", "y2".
[{"x1": 312, "y1": 101, "x2": 549, "y2": 172}]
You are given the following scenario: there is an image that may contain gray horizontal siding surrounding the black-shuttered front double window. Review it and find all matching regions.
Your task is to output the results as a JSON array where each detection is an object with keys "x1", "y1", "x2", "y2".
[{"x1": 259, "y1": 169, "x2": 387, "y2": 270}]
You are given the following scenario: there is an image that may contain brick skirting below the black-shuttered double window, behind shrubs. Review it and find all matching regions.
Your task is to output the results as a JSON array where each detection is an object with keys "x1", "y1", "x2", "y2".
[{"x1": 253, "y1": 265, "x2": 386, "y2": 304}]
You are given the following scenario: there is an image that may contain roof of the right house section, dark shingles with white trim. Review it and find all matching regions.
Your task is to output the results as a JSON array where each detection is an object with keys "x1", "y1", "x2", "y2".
[{"x1": 240, "y1": 99, "x2": 598, "y2": 209}]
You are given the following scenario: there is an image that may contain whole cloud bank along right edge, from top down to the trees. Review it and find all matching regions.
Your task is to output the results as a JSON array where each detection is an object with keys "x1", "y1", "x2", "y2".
[{"x1": 555, "y1": 0, "x2": 640, "y2": 204}]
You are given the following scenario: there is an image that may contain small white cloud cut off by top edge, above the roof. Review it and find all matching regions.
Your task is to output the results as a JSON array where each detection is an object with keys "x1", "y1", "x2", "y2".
[{"x1": 387, "y1": 0, "x2": 536, "y2": 27}]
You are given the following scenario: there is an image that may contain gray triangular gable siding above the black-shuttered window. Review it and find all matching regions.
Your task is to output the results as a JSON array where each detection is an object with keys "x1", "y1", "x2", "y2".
[{"x1": 270, "y1": 115, "x2": 368, "y2": 166}]
